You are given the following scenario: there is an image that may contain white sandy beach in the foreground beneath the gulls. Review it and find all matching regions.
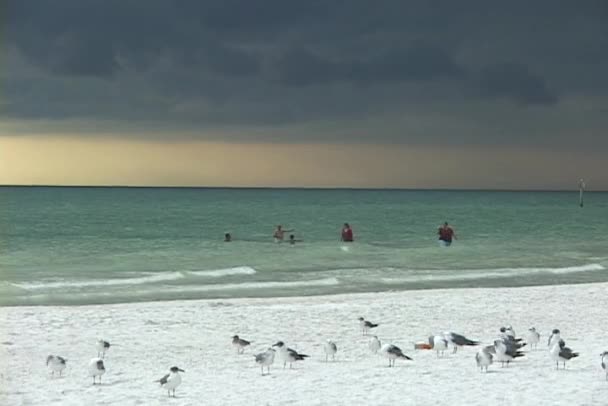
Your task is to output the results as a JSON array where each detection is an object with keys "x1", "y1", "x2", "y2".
[{"x1": 0, "y1": 284, "x2": 608, "y2": 406}]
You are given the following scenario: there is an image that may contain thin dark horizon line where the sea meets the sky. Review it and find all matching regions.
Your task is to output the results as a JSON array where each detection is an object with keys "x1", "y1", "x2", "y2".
[{"x1": 0, "y1": 184, "x2": 608, "y2": 193}]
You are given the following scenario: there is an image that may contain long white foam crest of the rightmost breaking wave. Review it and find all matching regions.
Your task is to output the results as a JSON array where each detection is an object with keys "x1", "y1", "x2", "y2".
[{"x1": 379, "y1": 264, "x2": 606, "y2": 284}]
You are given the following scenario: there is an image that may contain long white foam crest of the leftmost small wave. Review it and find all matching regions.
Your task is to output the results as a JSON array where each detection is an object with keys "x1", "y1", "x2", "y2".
[{"x1": 12, "y1": 272, "x2": 184, "y2": 290}]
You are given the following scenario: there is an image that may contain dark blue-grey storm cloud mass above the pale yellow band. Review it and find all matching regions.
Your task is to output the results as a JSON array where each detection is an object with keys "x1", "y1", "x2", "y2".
[{"x1": 0, "y1": 0, "x2": 608, "y2": 143}]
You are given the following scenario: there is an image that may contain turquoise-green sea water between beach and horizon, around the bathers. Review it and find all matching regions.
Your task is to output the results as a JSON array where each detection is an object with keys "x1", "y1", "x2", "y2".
[{"x1": 0, "y1": 187, "x2": 608, "y2": 306}]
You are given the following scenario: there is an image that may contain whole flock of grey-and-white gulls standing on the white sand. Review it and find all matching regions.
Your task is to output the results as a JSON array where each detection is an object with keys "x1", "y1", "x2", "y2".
[{"x1": 46, "y1": 317, "x2": 608, "y2": 397}]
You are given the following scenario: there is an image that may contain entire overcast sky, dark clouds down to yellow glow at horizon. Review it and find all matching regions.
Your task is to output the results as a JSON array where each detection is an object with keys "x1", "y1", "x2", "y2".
[{"x1": 0, "y1": 0, "x2": 608, "y2": 189}]
